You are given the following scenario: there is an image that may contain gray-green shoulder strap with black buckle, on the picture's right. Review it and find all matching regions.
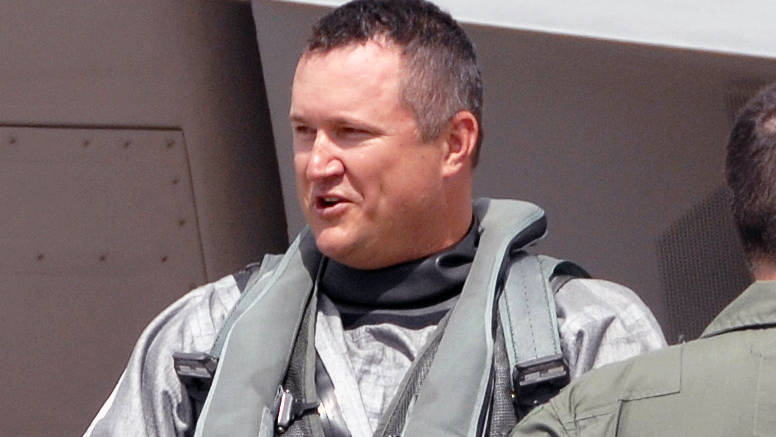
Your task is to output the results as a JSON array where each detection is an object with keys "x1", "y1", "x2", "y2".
[{"x1": 498, "y1": 251, "x2": 589, "y2": 417}]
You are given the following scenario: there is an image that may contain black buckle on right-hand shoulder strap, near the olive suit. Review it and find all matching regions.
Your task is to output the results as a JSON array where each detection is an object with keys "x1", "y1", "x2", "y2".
[{"x1": 512, "y1": 354, "x2": 570, "y2": 417}]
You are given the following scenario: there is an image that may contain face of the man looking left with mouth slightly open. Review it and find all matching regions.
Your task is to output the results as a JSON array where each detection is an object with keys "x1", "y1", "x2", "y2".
[{"x1": 290, "y1": 41, "x2": 448, "y2": 269}]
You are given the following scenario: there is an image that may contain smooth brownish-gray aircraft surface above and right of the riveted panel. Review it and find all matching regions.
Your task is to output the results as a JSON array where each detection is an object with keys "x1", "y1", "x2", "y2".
[{"x1": 0, "y1": 0, "x2": 287, "y2": 278}]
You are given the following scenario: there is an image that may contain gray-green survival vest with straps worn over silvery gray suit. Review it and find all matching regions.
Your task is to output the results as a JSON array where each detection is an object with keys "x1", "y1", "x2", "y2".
[{"x1": 174, "y1": 199, "x2": 588, "y2": 437}]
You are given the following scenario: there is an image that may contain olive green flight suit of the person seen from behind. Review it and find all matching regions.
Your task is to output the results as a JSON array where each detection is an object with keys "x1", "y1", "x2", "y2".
[{"x1": 511, "y1": 281, "x2": 776, "y2": 437}]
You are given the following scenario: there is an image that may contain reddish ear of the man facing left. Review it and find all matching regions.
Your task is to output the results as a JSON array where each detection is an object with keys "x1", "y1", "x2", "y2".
[{"x1": 442, "y1": 111, "x2": 480, "y2": 176}]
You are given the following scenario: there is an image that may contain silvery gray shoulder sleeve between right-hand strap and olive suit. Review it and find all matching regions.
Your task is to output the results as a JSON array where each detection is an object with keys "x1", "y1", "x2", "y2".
[{"x1": 555, "y1": 279, "x2": 666, "y2": 379}]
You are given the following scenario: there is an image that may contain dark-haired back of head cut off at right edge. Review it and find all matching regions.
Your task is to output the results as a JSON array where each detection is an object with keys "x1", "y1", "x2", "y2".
[{"x1": 725, "y1": 80, "x2": 776, "y2": 270}]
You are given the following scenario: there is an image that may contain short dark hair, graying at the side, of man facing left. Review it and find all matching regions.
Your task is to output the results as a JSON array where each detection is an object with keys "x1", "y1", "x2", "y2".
[{"x1": 305, "y1": 0, "x2": 482, "y2": 164}]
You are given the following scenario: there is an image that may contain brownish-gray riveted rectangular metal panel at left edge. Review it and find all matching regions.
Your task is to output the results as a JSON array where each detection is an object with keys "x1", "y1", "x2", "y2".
[{"x1": 0, "y1": 126, "x2": 205, "y2": 278}]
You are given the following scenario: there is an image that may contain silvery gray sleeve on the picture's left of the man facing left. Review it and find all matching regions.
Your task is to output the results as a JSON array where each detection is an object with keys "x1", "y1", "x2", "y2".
[{"x1": 84, "y1": 275, "x2": 240, "y2": 437}]
